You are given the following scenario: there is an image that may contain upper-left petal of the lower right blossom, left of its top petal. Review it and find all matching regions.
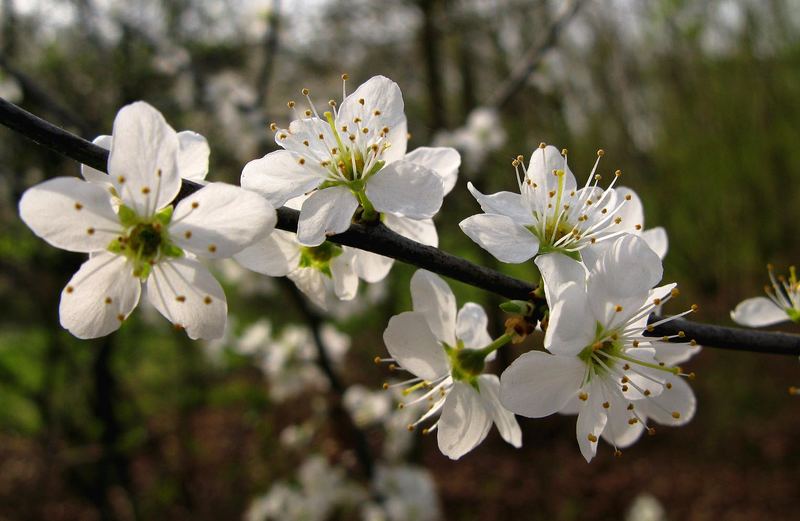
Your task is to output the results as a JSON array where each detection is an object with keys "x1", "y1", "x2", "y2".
[{"x1": 544, "y1": 282, "x2": 597, "y2": 355}]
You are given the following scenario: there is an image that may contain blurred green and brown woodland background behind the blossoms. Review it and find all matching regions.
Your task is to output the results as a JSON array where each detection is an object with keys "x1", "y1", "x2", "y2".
[{"x1": 0, "y1": 0, "x2": 800, "y2": 520}]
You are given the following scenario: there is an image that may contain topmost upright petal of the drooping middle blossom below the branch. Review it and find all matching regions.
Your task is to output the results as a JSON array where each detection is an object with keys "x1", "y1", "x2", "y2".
[{"x1": 411, "y1": 270, "x2": 456, "y2": 347}]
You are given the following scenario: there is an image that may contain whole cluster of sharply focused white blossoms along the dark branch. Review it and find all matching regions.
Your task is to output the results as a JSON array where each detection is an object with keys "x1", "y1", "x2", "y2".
[{"x1": 19, "y1": 75, "x2": 708, "y2": 461}]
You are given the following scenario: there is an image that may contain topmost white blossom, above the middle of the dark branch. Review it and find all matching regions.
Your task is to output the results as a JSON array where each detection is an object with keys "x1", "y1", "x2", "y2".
[{"x1": 242, "y1": 76, "x2": 461, "y2": 260}]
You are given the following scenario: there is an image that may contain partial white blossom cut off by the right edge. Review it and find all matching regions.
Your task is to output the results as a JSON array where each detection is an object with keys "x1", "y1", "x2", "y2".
[{"x1": 731, "y1": 264, "x2": 800, "y2": 327}]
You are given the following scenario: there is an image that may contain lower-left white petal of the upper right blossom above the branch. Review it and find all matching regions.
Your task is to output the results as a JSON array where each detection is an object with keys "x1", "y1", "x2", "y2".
[{"x1": 458, "y1": 214, "x2": 539, "y2": 264}]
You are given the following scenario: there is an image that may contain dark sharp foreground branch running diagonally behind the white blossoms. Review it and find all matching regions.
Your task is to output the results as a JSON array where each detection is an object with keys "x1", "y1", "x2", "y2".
[{"x1": 0, "y1": 98, "x2": 800, "y2": 356}]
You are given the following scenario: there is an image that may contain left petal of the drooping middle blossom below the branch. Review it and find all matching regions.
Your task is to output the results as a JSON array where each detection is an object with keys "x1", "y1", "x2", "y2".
[{"x1": 383, "y1": 311, "x2": 450, "y2": 381}]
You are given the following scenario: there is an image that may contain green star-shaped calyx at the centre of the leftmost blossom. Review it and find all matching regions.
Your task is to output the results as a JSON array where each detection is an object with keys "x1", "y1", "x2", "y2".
[{"x1": 107, "y1": 205, "x2": 183, "y2": 280}]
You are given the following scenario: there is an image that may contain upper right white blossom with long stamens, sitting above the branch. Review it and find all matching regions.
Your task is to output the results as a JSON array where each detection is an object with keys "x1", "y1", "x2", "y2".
[{"x1": 460, "y1": 144, "x2": 667, "y2": 263}]
